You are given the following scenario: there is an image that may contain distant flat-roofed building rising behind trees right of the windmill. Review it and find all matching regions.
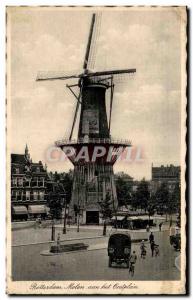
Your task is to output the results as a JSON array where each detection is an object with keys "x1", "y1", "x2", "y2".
[{"x1": 151, "y1": 165, "x2": 181, "y2": 193}]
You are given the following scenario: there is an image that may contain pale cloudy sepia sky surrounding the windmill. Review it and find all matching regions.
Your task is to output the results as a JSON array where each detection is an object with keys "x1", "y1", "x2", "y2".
[{"x1": 7, "y1": 7, "x2": 183, "y2": 179}]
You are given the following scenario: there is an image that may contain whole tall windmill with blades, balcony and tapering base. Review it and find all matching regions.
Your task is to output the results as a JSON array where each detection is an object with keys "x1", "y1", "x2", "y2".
[{"x1": 37, "y1": 14, "x2": 136, "y2": 224}]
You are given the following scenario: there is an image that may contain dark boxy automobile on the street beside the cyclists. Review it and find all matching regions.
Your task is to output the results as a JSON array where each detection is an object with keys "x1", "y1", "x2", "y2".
[{"x1": 108, "y1": 232, "x2": 131, "y2": 268}]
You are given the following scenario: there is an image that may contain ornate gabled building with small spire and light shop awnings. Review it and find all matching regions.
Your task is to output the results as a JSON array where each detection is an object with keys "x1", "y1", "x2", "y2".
[{"x1": 11, "y1": 145, "x2": 49, "y2": 219}]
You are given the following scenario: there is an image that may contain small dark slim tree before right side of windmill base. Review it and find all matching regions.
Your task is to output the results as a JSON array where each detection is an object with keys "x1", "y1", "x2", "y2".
[{"x1": 99, "y1": 192, "x2": 113, "y2": 236}]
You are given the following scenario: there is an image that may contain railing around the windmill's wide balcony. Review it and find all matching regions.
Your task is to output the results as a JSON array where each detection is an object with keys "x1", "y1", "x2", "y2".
[{"x1": 55, "y1": 138, "x2": 131, "y2": 147}]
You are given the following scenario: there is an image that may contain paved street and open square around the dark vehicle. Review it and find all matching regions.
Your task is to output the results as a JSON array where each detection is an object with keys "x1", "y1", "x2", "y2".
[{"x1": 12, "y1": 228, "x2": 180, "y2": 281}]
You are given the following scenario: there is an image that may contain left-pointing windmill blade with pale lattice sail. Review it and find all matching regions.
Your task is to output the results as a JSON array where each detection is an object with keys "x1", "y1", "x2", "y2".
[{"x1": 36, "y1": 71, "x2": 81, "y2": 81}]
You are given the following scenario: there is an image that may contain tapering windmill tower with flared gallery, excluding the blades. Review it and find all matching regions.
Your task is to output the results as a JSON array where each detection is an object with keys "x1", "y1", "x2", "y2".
[{"x1": 56, "y1": 79, "x2": 131, "y2": 225}]
